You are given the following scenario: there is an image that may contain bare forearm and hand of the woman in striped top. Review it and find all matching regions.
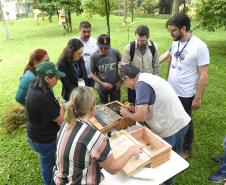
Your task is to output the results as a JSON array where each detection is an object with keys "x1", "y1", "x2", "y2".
[{"x1": 100, "y1": 145, "x2": 143, "y2": 175}]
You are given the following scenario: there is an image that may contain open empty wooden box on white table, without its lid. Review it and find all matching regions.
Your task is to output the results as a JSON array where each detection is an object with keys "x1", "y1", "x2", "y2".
[{"x1": 130, "y1": 127, "x2": 172, "y2": 167}]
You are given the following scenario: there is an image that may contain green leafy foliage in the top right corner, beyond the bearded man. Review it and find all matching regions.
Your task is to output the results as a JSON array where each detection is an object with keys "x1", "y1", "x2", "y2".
[{"x1": 196, "y1": 0, "x2": 226, "y2": 31}]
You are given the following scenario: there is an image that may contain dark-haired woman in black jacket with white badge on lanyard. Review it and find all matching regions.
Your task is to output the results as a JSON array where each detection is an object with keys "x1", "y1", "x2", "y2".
[{"x1": 58, "y1": 39, "x2": 88, "y2": 101}]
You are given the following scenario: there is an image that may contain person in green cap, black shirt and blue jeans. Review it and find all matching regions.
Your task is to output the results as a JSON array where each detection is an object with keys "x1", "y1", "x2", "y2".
[{"x1": 25, "y1": 61, "x2": 65, "y2": 185}]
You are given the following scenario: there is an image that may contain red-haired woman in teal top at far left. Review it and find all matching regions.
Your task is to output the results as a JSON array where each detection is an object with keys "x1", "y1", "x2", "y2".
[{"x1": 15, "y1": 49, "x2": 49, "y2": 105}]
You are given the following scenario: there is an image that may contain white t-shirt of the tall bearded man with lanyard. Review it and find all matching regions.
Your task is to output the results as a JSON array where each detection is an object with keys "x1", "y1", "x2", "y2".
[{"x1": 168, "y1": 36, "x2": 210, "y2": 97}]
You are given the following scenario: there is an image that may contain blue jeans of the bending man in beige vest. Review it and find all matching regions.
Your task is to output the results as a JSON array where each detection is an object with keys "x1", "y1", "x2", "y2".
[{"x1": 163, "y1": 124, "x2": 189, "y2": 185}]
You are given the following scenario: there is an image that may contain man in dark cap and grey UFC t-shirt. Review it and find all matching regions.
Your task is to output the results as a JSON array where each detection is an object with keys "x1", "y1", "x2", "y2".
[{"x1": 90, "y1": 34, "x2": 121, "y2": 103}]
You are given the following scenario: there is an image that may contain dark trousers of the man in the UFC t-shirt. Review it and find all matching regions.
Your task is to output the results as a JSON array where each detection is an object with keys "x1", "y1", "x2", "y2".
[{"x1": 97, "y1": 87, "x2": 120, "y2": 104}]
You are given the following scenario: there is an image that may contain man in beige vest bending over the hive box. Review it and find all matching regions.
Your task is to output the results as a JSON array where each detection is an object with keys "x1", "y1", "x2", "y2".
[{"x1": 120, "y1": 65, "x2": 191, "y2": 185}]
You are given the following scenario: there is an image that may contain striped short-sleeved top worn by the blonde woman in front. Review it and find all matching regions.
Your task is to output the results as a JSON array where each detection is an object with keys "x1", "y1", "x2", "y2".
[{"x1": 54, "y1": 120, "x2": 111, "y2": 185}]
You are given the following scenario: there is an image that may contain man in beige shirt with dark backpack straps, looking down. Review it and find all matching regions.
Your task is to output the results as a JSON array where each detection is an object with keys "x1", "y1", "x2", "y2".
[{"x1": 121, "y1": 25, "x2": 160, "y2": 103}]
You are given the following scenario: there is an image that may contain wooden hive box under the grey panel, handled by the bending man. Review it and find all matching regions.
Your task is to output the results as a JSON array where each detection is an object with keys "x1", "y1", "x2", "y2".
[{"x1": 90, "y1": 101, "x2": 135, "y2": 132}]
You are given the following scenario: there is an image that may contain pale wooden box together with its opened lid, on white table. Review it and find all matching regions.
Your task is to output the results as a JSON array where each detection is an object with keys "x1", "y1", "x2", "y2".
[{"x1": 110, "y1": 127, "x2": 172, "y2": 177}]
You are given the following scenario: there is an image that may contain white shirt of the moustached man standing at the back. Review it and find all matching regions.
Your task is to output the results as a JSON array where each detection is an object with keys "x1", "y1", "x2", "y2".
[{"x1": 77, "y1": 37, "x2": 98, "y2": 78}]
